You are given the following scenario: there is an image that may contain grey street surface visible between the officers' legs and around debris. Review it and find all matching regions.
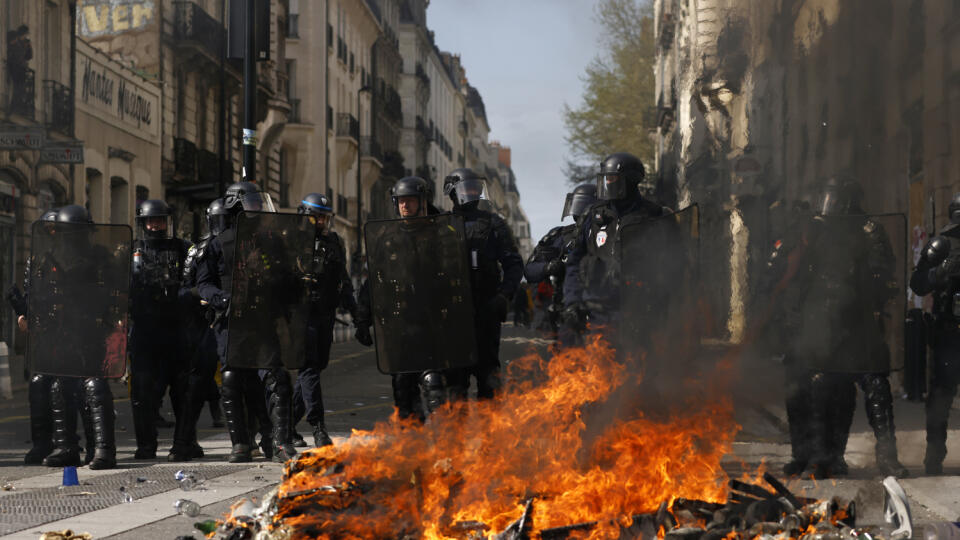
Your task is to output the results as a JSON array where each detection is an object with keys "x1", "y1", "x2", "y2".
[{"x1": 0, "y1": 325, "x2": 960, "y2": 540}]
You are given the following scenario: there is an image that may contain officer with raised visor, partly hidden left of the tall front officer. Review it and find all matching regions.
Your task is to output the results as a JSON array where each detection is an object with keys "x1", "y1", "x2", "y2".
[{"x1": 523, "y1": 183, "x2": 597, "y2": 343}]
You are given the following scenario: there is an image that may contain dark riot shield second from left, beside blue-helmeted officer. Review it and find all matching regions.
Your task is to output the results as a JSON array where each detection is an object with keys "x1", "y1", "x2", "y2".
[{"x1": 226, "y1": 212, "x2": 315, "y2": 369}]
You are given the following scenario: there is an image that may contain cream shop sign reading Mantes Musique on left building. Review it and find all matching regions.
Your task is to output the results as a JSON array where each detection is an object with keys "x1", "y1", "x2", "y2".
[{"x1": 76, "y1": 42, "x2": 160, "y2": 141}]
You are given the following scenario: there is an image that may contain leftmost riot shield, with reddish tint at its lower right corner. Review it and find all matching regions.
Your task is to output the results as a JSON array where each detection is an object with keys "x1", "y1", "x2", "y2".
[{"x1": 27, "y1": 221, "x2": 132, "y2": 378}]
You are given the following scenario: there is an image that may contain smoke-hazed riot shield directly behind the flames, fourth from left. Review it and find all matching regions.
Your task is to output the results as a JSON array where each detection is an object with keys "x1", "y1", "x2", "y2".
[{"x1": 618, "y1": 205, "x2": 702, "y2": 366}]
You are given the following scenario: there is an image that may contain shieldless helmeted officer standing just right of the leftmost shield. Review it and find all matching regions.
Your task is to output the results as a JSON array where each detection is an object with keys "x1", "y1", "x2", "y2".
[{"x1": 130, "y1": 200, "x2": 189, "y2": 459}]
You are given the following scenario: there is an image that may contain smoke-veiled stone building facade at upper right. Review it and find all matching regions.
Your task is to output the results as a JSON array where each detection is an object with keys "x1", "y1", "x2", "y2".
[{"x1": 654, "y1": 0, "x2": 960, "y2": 342}]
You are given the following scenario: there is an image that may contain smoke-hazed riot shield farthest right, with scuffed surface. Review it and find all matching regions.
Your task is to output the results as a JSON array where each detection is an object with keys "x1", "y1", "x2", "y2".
[{"x1": 787, "y1": 214, "x2": 907, "y2": 373}]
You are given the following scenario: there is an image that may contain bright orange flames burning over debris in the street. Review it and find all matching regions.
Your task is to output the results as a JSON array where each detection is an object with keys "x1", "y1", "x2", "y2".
[{"x1": 272, "y1": 338, "x2": 738, "y2": 539}]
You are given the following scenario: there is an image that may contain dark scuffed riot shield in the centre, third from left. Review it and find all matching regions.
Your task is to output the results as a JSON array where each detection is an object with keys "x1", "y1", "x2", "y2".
[{"x1": 364, "y1": 214, "x2": 477, "y2": 373}]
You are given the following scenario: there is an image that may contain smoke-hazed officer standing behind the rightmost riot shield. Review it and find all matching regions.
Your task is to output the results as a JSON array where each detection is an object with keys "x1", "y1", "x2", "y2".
[{"x1": 787, "y1": 177, "x2": 908, "y2": 478}]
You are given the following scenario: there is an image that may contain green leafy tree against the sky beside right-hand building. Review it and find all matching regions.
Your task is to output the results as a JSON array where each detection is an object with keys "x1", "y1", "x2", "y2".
[{"x1": 563, "y1": 0, "x2": 656, "y2": 183}]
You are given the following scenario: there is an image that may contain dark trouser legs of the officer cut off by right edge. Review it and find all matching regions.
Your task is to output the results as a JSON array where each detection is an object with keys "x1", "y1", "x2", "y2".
[{"x1": 923, "y1": 327, "x2": 960, "y2": 474}]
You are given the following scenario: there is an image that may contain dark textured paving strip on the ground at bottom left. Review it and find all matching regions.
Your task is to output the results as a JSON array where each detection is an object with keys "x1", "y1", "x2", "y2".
[{"x1": 0, "y1": 464, "x2": 250, "y2": 536}]
